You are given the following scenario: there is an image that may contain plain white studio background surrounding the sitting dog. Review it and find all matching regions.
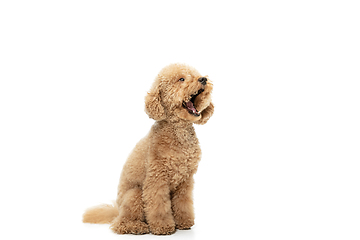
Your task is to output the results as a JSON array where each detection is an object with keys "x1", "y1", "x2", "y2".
[{"x1": 0, "y1": 0, "x2": 360, "y2": 240}]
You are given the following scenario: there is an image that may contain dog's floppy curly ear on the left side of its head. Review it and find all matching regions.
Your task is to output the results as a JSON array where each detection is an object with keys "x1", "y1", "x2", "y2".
[{"x1": 145, "y1": 86, "x2": 166, "y2": 121}]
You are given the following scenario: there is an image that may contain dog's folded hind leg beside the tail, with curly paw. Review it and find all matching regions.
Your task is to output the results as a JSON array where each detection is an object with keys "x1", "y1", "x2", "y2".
[{"x1": 110, "y1": 187, "x2": 149, "y2": 234}]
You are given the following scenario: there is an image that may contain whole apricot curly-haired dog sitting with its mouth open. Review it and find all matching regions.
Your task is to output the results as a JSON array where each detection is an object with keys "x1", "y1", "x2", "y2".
[{"x1": 83, "y1": 64, "x2": 214, "y2": 234}]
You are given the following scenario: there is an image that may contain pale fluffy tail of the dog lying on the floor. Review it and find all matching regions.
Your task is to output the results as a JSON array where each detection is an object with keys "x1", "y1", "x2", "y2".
[{"x1": 83, "y1": 203, "x2": 119, "y2": 223}]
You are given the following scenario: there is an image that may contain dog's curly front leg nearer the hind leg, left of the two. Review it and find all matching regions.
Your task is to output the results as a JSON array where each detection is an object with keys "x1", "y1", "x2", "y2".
[{"x1": 143, "y1": 161, "x2": 175, "y2": 235}]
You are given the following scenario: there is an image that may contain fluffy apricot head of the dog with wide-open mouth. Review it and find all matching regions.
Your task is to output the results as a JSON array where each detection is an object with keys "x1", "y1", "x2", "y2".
[{"x1": 145, "y1": 64, "x2": 214, "y2": 124}]
